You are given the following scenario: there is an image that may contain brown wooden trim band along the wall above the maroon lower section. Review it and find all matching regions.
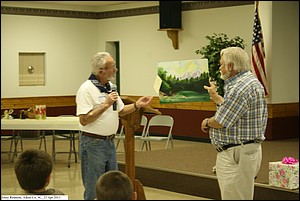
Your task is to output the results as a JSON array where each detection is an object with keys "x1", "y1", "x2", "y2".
[{"x1": 1, "y1": 96, "x2": 299, "y2": 118}]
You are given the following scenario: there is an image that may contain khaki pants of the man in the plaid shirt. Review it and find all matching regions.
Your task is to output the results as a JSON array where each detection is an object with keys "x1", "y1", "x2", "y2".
[{"x1": 216, "y1": 143, "x2": 262, "y2": 200}]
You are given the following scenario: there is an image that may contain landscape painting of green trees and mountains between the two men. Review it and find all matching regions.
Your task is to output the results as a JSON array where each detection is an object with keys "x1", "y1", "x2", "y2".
[{"x1": 157, "y1": 59, "x2": 210, "y2": 104}]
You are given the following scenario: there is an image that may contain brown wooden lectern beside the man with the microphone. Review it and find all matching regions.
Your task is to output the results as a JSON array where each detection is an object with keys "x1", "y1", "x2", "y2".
[{"x1": 120, "y1": 96, "x2": 161, "y2": 200}]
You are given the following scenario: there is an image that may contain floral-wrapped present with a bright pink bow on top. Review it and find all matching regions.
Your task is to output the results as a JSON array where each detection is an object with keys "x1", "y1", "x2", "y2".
[{"x1": 269, "y1": 157, "x2": 299, "y2": 189}]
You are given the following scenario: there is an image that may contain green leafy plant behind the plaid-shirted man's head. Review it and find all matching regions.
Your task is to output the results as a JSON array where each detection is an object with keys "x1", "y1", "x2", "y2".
[{"x1": 196, "y1": 33, "x2": 246, "y2": 96}]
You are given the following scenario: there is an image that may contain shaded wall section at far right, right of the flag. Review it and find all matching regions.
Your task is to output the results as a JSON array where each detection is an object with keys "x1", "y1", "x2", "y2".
[{"x1": 270, "y1": 1, "x2": 299, "y2": 103}]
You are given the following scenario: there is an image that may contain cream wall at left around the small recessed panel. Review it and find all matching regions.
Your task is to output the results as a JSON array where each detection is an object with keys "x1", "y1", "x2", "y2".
[{"x1": 1, "y1": 15, "x2": 99, "y2": 98}]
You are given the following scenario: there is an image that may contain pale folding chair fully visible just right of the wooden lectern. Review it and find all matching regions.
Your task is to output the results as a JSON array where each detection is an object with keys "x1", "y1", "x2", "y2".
[{"x1": 140, "y1": 115, "x2": 174, "y2": 151}]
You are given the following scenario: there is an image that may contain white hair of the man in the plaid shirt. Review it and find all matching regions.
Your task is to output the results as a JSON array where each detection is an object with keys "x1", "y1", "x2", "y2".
[{"x1": 220, "y1": 47, "x2": 251, "y2": 73}]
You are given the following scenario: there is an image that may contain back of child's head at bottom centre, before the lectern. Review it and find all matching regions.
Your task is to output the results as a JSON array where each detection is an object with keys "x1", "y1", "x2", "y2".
[{"x1": 96, "y1": 170, "x2": 136, "y2": 200}]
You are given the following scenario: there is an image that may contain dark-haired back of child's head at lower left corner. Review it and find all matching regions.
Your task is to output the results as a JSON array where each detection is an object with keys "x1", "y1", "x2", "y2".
[{"x1": 14, "y1": 149, "x2": 53, "y2": 192}]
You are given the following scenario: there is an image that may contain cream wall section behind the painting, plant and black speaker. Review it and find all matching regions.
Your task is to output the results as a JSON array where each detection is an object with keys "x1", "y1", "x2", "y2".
[{"x1": 98, "y1": 6, "x2": 253, "y2": 95}]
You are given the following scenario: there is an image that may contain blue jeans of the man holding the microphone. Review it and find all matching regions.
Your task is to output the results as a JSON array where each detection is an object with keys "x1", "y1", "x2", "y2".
[{"x1": 80, "y1": 135, "x2": 118, "y2": 200}]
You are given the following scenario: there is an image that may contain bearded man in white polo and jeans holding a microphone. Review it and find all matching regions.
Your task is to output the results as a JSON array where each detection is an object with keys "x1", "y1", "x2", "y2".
[{"x1": 76, "y1": 52, "x2": 152, "y2": 200}]
